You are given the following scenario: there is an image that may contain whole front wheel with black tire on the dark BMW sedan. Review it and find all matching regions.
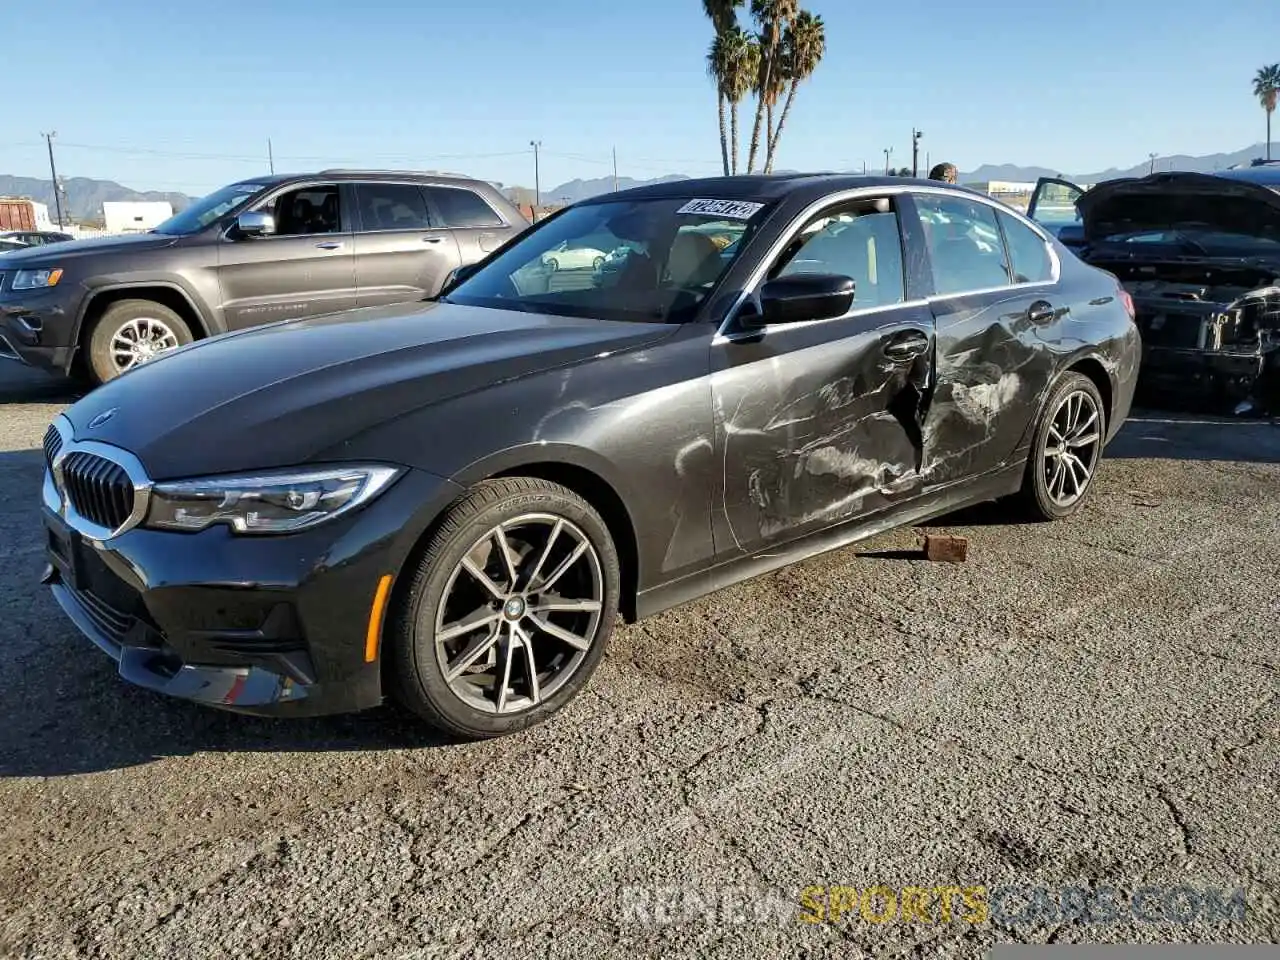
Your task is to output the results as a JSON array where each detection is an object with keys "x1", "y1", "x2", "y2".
[{"x1": 384, "y1": 477, "x2": 622, "y2": 740}]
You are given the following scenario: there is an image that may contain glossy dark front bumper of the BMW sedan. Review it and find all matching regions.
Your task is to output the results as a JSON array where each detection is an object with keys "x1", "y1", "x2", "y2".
[{"x1": 44, "y1": 470, "x2": 468, "y2": 716}]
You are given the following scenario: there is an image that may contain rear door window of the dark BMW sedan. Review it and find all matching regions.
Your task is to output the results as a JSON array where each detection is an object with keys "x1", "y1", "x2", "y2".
[{"x1": 914, "y1": 193, "x2": 1011, "y2": 294}]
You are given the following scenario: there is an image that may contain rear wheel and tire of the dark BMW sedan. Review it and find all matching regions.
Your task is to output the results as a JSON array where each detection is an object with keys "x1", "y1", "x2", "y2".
[{"x1": 1019, "y1": 371, "x2": 1107, "y2": 521}]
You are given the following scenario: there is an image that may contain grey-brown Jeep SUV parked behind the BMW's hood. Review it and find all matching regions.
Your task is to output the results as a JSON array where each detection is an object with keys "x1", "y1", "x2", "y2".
[{"x1": 0, "y1": 170, "x2": 529, "y2": 384}]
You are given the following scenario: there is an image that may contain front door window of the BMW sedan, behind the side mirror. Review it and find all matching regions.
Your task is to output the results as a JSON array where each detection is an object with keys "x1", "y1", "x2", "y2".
[{"x1": 769, "y1": 200, "x2": 906, "y2": 310}]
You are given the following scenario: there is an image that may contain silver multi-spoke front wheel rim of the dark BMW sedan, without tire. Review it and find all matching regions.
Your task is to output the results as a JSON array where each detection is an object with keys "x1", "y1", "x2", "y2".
[{"x1": 435, "y1": 513, "x2": 604, "y2": 713}]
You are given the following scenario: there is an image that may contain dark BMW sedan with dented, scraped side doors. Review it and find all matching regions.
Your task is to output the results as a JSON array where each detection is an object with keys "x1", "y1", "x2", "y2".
[{"x1": 42, "y1": 174, "x2": 1139, "y2": 737}]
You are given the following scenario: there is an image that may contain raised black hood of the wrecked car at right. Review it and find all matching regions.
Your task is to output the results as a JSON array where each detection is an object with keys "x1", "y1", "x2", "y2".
[{"x1": 1076, "y1": 173, "x2": 1280, "y2": 241}]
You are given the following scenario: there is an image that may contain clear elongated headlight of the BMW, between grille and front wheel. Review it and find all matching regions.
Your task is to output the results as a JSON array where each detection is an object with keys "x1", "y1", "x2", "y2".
[{"x1": 145, "y1": 466, "x2": 402, "y2": 534}]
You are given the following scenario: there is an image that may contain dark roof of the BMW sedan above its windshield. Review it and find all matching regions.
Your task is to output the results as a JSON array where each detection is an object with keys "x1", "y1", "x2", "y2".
[{"x1": 596, "y1": 173, "x2": 982, "y2": 202}]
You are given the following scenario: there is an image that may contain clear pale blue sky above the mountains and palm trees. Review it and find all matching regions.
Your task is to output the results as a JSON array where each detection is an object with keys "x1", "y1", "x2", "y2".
[{"x1": 0, "y1": 0, "x2": 1280, "y2": 193}]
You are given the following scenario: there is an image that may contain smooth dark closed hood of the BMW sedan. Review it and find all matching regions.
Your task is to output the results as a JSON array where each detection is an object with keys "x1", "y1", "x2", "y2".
[{"x1": 67, "y1": 303, "x2": 676, "y2": 480}]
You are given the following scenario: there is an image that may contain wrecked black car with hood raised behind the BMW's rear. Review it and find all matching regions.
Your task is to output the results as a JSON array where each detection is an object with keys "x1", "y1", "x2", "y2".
[{"x1": 1028, "y1": 164, "x2": 1280, "y2": 415}]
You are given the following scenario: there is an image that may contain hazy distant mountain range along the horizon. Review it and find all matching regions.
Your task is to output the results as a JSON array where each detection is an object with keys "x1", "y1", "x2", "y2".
[{"x1": 0, "y1": 143, "x2": 1277, "y2": 220}]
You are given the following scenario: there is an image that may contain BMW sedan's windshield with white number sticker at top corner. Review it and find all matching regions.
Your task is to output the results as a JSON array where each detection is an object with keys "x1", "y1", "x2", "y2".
[{"x1": 444, "y1": 197, "x2": 765, "y2": 324}]
